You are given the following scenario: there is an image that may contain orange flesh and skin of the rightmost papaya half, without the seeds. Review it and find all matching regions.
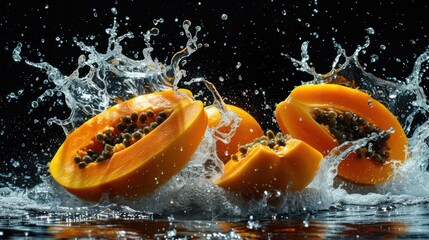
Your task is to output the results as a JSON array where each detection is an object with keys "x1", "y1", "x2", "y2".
[{"x1": 275, "y1": 84, "x2": 408, "y2": 185}]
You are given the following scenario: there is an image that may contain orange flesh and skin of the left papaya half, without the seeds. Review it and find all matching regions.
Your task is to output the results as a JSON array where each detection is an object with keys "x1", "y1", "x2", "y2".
[{"x1": 49, "y1": 90, "x2": 207, "y2": 201}]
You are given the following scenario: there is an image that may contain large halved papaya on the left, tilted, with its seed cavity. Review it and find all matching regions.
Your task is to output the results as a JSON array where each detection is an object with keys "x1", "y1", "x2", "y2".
[{"x1": 49, "y1": 90, "x2": 207, "y2": 201}]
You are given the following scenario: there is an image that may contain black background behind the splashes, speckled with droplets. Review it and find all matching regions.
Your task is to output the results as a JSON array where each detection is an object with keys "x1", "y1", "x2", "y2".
[{"x1": 0, "y1": 0, "x2": 429, "y2": 187}]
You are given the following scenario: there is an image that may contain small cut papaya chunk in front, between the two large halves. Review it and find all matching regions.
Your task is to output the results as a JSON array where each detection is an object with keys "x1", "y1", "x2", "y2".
[{"x1": 213, "y1": 130, "x2": 323, "y2": 198}]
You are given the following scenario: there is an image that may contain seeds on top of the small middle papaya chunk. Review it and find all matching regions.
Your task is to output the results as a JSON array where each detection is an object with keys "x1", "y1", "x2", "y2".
[{"x1": 231, "y1": 130, "x2": 290, "y2": 161}]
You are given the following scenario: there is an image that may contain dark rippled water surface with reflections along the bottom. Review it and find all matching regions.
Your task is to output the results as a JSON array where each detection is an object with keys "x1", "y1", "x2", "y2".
[{"x1": 0, "y1": 204, "x2": 429, "y2": 239}]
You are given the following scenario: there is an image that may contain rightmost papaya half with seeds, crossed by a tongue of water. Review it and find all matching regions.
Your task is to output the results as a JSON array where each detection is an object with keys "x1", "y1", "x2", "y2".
[{"x1": 275, "y1": 84, "x2": 408, "y2": 185}]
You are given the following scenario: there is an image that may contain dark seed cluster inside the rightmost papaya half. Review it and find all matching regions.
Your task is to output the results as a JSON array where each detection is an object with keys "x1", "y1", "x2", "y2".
[{"x1": 313, "y1": 108, "x2": 390, "y2": 163}]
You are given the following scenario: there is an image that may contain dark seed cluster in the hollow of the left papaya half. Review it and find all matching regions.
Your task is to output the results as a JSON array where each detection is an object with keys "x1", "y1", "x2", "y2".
[{"x1": 74, "y1": 110, "x2": 170, "y2": 169}]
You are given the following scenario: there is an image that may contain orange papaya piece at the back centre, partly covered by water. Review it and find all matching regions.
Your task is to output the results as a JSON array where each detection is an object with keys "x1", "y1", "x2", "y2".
[{"x1": 205, "y1": 104, "x2": 264, "y2": 163}]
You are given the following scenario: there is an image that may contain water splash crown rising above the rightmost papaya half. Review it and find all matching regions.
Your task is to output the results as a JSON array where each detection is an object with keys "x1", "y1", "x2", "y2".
[{"x1": 288, "y1": 37, "x2": 429, "y2": 136}]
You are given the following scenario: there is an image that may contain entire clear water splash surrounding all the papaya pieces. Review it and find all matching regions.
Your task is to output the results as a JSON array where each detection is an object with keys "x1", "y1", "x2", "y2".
[{"x1": 5, "y1": 19, "x2": 429, "y2": 218}]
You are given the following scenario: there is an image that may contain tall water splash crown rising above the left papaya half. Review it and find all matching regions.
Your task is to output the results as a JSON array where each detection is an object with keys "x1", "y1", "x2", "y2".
[{"x1": 13, "y1": 19, "x2": 201, "y2": 134}]
